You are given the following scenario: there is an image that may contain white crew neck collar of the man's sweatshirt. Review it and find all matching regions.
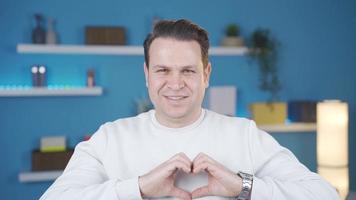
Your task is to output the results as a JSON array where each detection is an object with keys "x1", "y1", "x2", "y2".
[{"x1": 150, "y1": 108, "x2": 205, "y2": 132}]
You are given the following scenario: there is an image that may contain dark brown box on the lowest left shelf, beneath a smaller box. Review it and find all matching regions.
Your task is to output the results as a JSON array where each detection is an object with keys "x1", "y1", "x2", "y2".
[{"x1": 32, "y1": 149, "x2": 74, "y2": 171}]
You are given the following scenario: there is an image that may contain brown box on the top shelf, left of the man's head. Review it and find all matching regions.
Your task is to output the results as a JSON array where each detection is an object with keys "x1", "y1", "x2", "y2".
[{"x1": 85, "y1": 26, "x2": 126, "y2": 45}]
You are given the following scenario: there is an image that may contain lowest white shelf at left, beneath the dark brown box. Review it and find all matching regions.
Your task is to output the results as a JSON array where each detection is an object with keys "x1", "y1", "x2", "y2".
[{"x1": 18, "y1": 170, "x2": 63, "y2": 183}]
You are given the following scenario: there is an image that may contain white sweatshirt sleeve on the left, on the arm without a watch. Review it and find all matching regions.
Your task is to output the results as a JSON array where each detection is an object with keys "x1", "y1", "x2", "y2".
[{"x1": 40, "y1": 125, "x2": 142, "y2": 200}]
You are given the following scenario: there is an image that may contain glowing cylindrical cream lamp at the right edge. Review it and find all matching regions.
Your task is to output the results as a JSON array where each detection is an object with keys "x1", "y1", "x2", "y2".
[{"x1": 317, "y1": 100, "x2": 349, "y2": 199}]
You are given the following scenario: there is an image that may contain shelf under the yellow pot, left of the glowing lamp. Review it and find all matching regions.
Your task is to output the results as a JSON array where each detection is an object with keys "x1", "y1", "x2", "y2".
[{"x1": 258, "y1": 123, "x2": 316, "y2": 133}]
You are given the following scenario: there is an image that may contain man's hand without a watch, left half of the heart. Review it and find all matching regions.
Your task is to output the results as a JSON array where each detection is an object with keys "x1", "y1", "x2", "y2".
[{"x1": 138, "y1": 153, "x2": 192, "y2": 200}]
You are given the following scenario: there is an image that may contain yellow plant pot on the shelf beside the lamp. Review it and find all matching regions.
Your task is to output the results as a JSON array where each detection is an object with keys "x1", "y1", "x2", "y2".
[{"x1": 250, "y1": 102, "x2": 287, "y2": 125}]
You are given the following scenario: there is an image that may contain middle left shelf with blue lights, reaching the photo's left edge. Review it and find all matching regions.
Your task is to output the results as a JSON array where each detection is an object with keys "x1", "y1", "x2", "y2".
[{"x1": 0, "y1": 87, "x2": 103, "y2": 97}]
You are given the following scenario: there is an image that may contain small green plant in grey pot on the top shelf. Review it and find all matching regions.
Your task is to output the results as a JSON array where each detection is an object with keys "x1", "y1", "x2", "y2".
[{"x1": 221, "y1": 24, "x2": 244, "y2": 47}]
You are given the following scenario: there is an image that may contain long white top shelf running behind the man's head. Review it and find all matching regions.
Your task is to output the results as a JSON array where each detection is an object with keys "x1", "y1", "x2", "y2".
[{"x1": 17, "y1": 44, "x2": 248, "y2": 56}]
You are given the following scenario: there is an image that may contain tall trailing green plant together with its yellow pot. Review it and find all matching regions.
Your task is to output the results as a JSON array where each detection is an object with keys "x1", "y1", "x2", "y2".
[{"x1": 250, "y1": 28, "x2": 287, "y2": 124}]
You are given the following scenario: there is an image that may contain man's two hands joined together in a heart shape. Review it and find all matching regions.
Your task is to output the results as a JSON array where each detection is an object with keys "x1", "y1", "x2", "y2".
[{"x1": 139, "y1": 153, "x2": 242, "y2": 200}]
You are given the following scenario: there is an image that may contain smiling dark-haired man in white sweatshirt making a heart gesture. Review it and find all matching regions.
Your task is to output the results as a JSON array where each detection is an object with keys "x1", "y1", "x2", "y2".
[{"x1": 41, "y1": 20, "x2": 338, "y2": 200}]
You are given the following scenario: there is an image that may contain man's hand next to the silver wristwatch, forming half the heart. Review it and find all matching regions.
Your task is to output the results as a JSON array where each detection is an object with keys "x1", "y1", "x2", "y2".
[{"x1": 192, "y1": 153, "x2": 242, "y2": 199}]
